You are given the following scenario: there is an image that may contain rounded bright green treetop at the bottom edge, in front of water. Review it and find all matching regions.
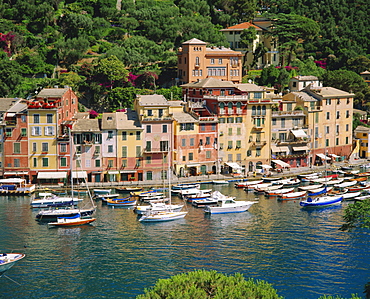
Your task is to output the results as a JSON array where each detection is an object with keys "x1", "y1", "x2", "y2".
[{"x1": 136, "y1": 270, "x2": 282, "y2": 299}]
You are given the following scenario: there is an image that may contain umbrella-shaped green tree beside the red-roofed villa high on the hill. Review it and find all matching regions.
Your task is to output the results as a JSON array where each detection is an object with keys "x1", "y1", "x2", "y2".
[{"x1": 270, "y1": 14, "x2": 320, "y2": 66}]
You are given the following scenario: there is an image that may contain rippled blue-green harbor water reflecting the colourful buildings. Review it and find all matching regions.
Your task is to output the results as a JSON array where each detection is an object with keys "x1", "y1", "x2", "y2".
[{"x1": 0, "y1": 183, "x2": 370, "y2": 299}]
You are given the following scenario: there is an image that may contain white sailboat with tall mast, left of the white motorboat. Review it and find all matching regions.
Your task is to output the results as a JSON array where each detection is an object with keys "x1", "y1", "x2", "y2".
[{"x1": 139, "y1": 141, "x2": 188, "y2": 222}]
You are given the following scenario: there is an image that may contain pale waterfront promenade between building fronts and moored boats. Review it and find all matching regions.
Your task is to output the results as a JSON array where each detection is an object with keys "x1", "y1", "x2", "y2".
[{"x1": 37, "y1": 159, "x2": 369, "y2": 189}]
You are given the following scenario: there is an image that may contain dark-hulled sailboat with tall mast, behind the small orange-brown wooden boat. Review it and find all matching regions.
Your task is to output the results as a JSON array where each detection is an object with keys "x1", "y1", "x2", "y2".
[{"x1": 36, "y1": 127, "x2": 96, "y2": 221}]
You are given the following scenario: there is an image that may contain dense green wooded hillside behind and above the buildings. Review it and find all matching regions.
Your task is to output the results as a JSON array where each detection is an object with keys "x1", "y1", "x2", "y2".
[{"x1": 0, "y1": 0, "x2": 370, "y2": 111}]
